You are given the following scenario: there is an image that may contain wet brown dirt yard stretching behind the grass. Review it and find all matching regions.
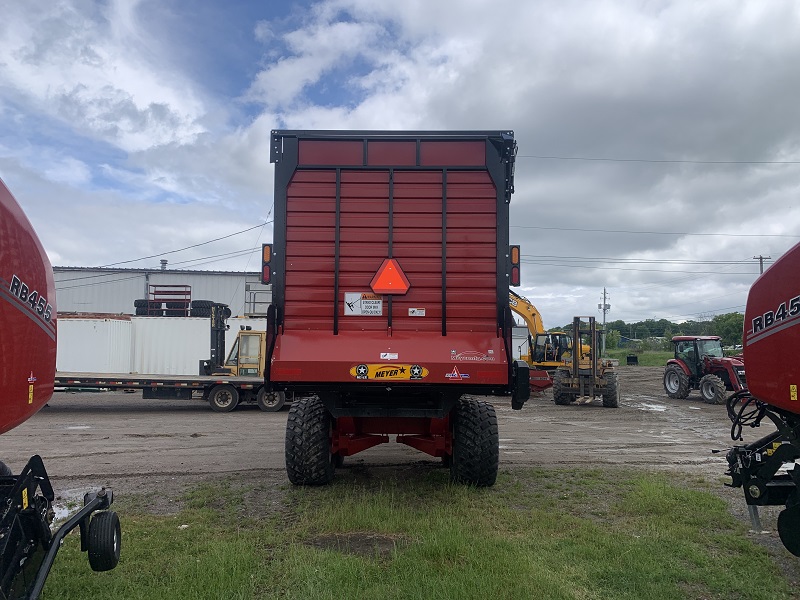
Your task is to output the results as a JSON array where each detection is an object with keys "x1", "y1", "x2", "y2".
[{"x1": 0, "y1": 366, "x2": 798, "y2": 573}]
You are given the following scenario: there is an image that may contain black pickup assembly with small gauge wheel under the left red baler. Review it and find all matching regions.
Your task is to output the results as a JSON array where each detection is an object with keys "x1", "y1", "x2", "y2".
[{"x1": 0, "y1": 455, "x2": 122, "y2": 600}]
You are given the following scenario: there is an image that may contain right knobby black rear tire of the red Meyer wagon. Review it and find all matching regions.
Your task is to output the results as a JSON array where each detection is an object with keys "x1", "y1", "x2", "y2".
[{"x1": 450, "y1": 398, "x2": 500, "y2": 487}]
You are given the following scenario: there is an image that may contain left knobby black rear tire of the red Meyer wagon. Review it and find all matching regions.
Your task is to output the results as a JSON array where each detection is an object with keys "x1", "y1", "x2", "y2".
[{"x1": 285, "y1": 396, "x2": 334, "y2": 485}]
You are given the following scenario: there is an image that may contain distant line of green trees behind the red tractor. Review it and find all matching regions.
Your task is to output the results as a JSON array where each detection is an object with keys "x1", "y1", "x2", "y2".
[{"x1": 562, "y1": 312, "x2": 744, "y2": 350}]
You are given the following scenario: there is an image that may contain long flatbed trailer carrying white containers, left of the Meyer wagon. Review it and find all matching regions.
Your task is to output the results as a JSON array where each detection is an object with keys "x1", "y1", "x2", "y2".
[{"x1": 55, "y1": 371, "x2": 272, "y2": 412}]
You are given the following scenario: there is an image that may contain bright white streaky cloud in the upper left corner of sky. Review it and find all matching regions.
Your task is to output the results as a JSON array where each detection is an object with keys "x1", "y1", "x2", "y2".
[{"x1": 0, "y1": 2, "x2": 209, "y2": 151}]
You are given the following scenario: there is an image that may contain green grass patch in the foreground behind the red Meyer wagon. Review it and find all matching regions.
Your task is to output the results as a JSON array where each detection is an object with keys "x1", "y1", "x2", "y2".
[{"x1": 42, "y1": 466, "x2": 792, "y2": 600}]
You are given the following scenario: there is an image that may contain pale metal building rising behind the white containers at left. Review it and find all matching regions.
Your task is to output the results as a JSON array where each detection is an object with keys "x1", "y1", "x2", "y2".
[{"x1": 53, "y1": 265, "x2": 272, "y2": 316}]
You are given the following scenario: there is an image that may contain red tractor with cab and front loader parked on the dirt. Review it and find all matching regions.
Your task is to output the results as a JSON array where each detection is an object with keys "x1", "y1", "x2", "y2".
[{"x1": 664, "y1": 335, "x2": 746, "y2": 404}]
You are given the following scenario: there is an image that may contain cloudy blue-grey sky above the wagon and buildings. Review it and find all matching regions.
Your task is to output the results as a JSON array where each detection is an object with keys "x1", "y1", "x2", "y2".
[{"x1": 0, "y1": 0, "x2": 800, "y2": 327}]
